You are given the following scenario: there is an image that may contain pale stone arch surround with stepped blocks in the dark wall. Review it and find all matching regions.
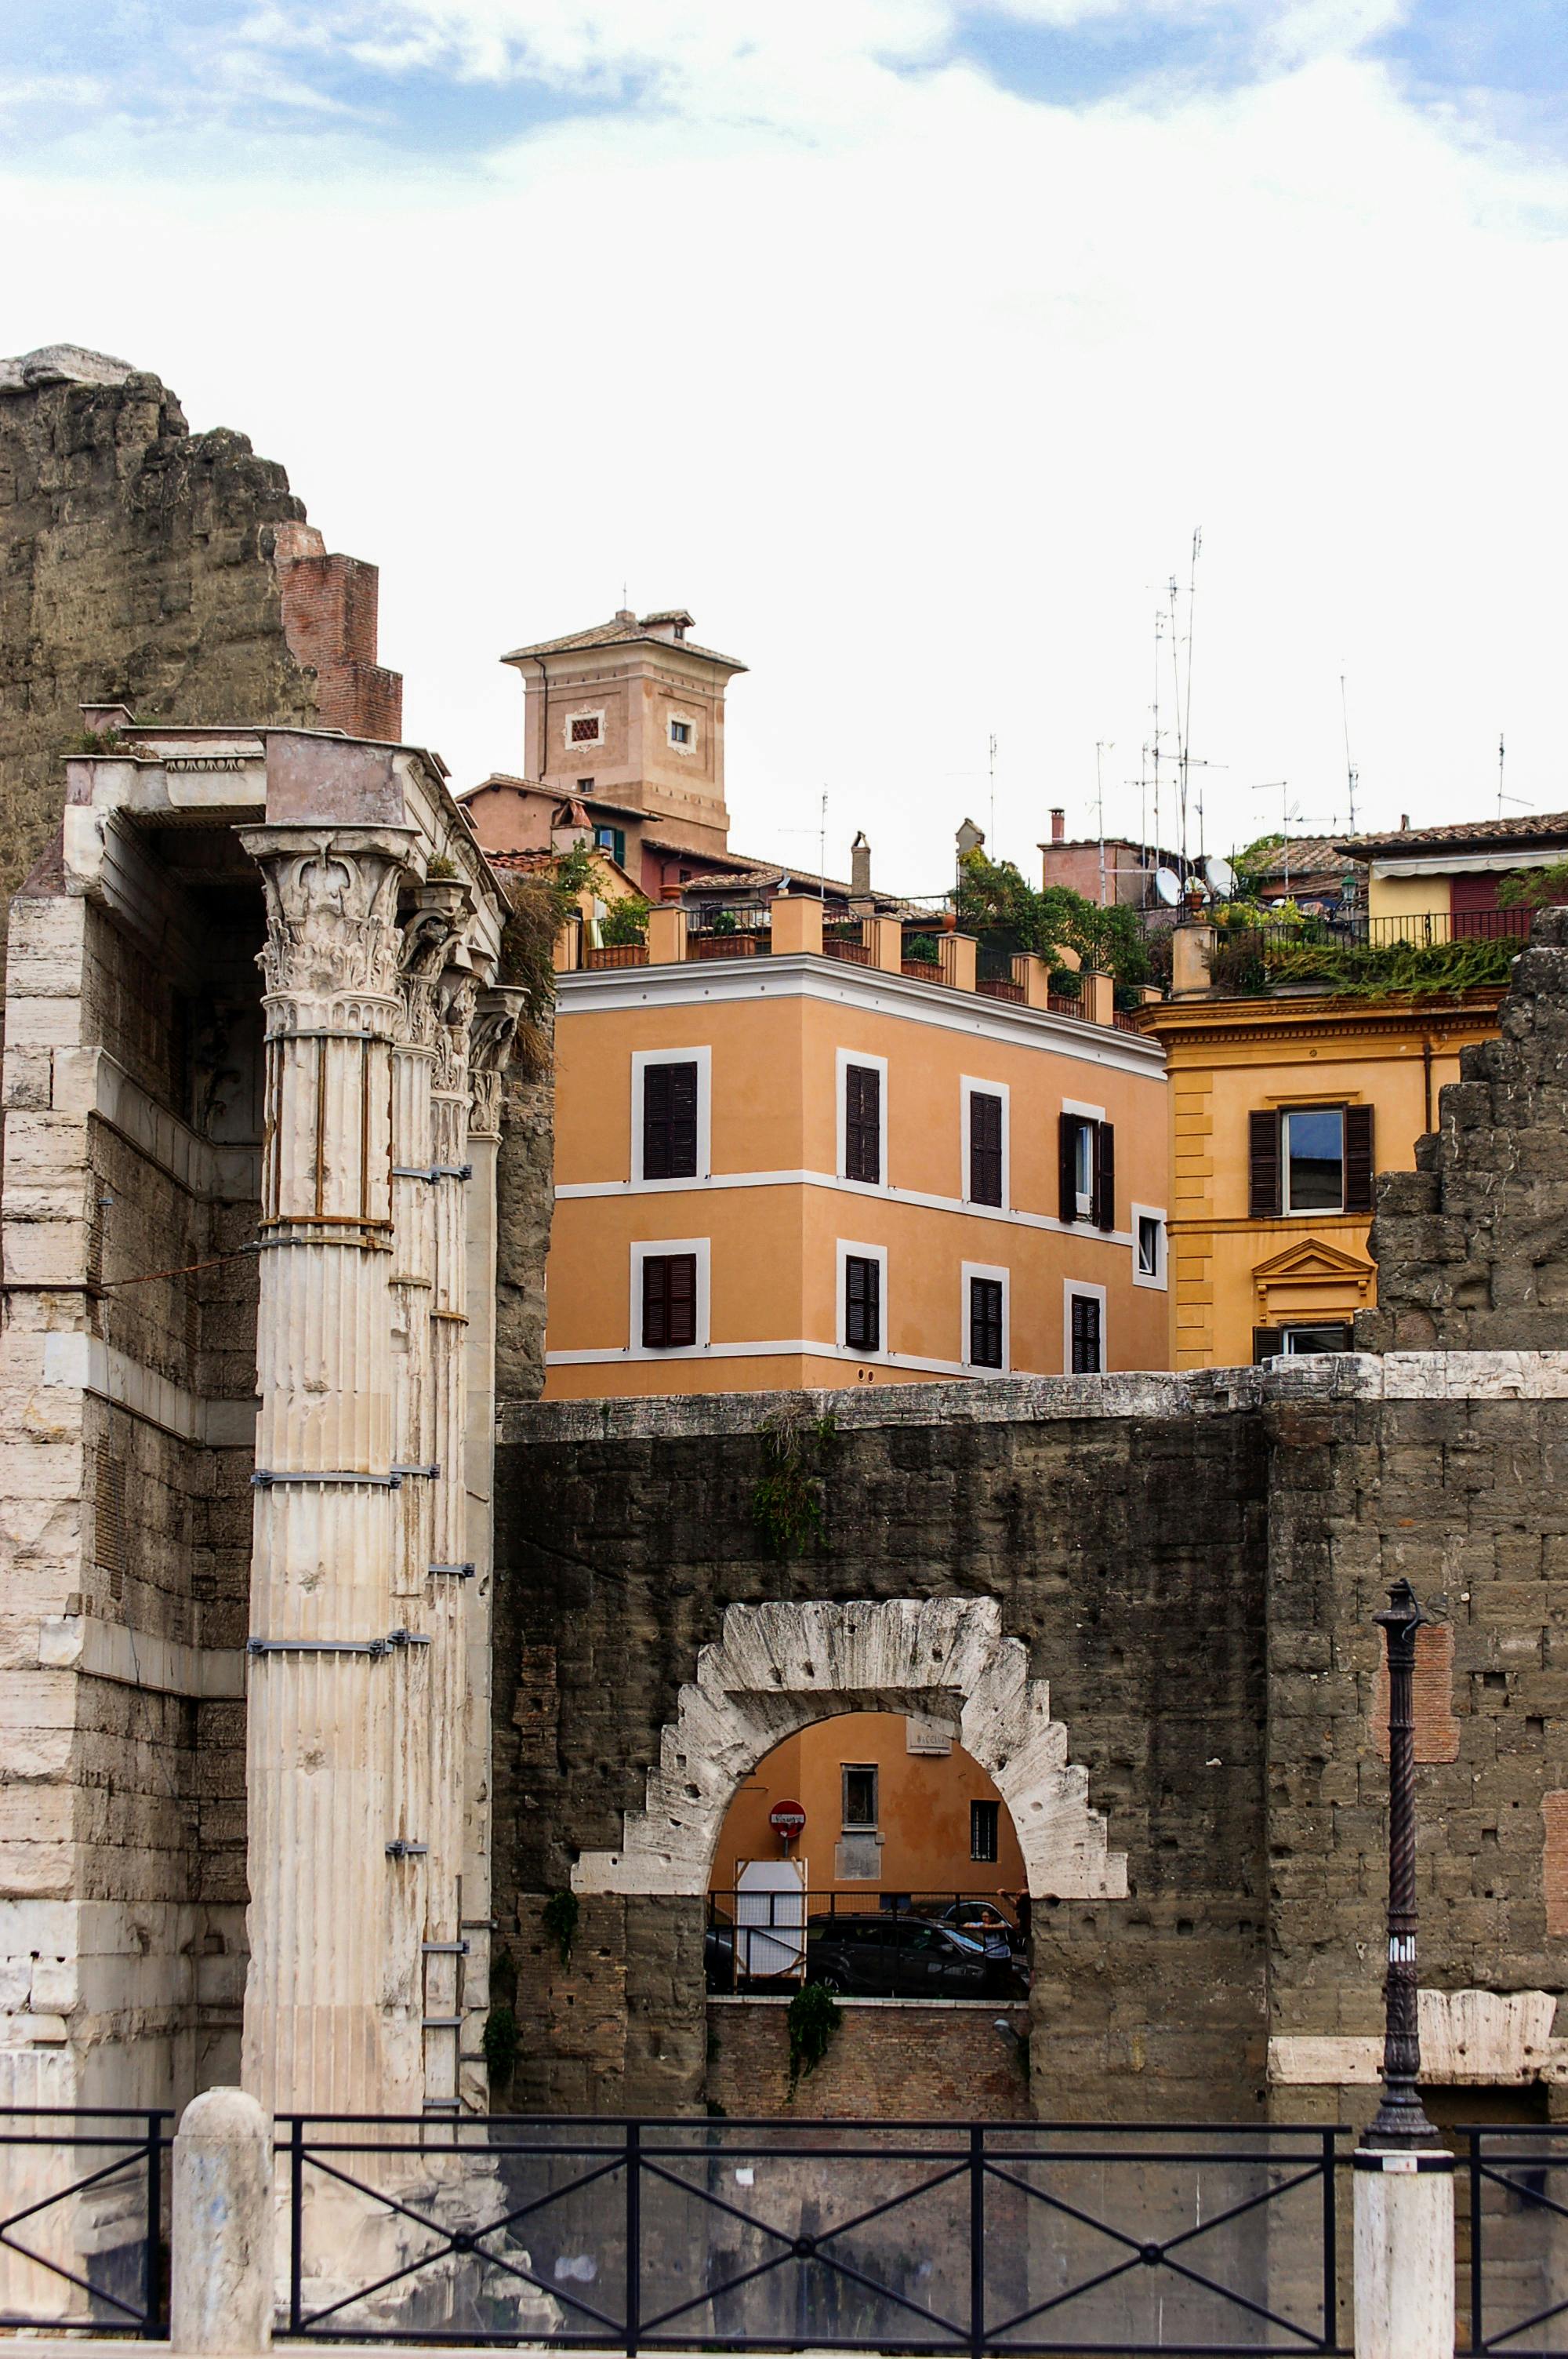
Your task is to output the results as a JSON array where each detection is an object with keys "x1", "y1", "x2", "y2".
[{"x1": 571, "y1": 1597, "x2": 1127, "y2": 1899}]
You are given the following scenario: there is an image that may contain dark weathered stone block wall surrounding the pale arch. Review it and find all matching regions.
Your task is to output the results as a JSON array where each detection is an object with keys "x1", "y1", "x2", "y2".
[{"x1": 495, "y1": 1354, "x2": 1568, "y2": 2118}]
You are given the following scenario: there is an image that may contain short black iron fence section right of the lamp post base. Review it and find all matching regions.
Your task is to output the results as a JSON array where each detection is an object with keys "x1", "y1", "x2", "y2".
[{"x1": 1457, "y1": 2128, "x2": 1568, "y2": 2359}]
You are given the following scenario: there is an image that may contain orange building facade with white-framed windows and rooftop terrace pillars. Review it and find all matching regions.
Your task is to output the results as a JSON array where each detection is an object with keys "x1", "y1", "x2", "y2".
[{"x1": 545, "y1": 896, "x2": 1167, "y2": 1399}]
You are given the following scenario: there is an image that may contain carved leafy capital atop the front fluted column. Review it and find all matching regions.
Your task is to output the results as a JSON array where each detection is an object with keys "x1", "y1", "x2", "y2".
[{"x1": 241, "y1": 826, "x2": 412, "y2": 1038}]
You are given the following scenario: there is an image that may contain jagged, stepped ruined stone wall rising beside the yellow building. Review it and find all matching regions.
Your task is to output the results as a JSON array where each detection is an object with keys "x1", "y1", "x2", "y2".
[{"x1": 1356, "y1": 908, "x2": 1568, "y2": 1352}]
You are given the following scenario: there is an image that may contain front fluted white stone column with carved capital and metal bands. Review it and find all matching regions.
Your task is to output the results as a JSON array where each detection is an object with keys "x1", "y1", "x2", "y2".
[{"x1": 243, "y1": 826, "x2": 422, "y2": 2111}]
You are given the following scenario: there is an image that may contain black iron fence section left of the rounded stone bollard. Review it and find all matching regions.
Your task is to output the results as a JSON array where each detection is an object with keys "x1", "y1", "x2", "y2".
[{"x1": 0, "y1": 2106, "x2": 175, "y2": 2340}]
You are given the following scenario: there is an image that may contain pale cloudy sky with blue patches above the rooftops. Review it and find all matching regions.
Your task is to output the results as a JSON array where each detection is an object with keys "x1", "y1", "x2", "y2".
[{"x1": 0, "y1": 0, "x2": 1568, "y2": 892}]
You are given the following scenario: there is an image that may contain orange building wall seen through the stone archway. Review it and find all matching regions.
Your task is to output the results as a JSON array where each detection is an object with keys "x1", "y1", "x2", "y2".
[{"x1": 710, "y1": 1713, "x2": 1028, "y2": 1899}]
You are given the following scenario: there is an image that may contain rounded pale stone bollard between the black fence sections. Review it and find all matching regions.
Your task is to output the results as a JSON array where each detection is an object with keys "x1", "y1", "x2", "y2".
[{"x1": 170, "y1": 2088, "x2": 274, "y2": 2359}]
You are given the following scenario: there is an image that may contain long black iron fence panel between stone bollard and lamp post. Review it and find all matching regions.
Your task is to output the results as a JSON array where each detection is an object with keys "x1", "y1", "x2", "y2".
[{"x1": 278, "y1": 2116, "x2": 1346, "y2": 2359}]
